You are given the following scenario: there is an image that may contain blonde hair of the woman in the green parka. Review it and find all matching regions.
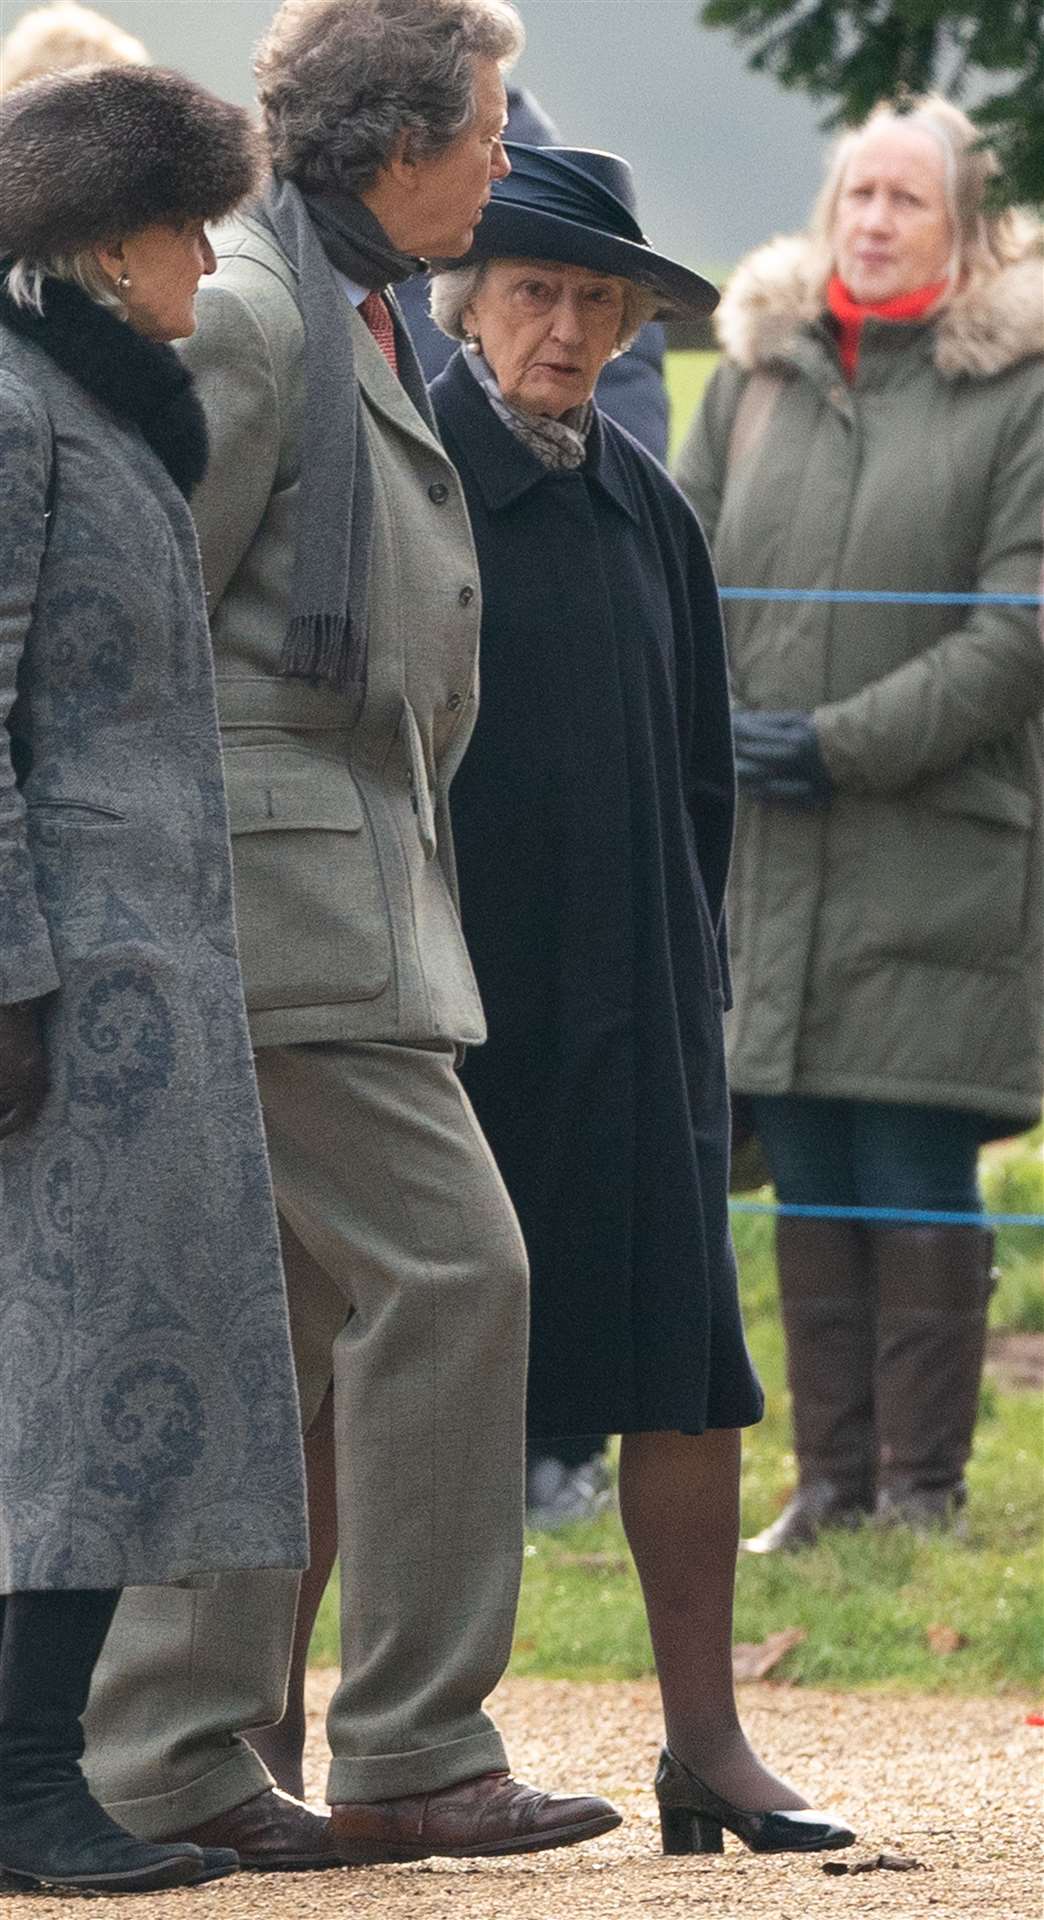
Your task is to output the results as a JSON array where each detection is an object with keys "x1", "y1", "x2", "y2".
[{"x1": 812, "y1": 94, "x2": 1040, "y2": 305}]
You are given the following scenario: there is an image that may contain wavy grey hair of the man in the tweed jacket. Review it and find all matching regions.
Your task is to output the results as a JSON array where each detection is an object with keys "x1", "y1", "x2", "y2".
[{"x1": 253, "y1": 0, "x2": 526, "y2": 192}]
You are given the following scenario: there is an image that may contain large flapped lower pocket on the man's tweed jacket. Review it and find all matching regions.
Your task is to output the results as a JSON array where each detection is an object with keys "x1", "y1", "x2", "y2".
[{"x1": 225, "y1": 745, "x2": 392, "y2": 1012}]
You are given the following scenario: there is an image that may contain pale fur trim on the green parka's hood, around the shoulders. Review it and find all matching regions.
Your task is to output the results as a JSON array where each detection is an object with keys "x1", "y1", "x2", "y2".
[{"x1": 714, "y1": 234, "x2": 1044, "y2": 380}]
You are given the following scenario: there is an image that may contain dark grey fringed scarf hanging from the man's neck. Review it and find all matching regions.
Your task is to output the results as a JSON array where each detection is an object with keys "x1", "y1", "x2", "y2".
[{"x1": 257, "y1": 179, "x2": 436, "y2": 699}]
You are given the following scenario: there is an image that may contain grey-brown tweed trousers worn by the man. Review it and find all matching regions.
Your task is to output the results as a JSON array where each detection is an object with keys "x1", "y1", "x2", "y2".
[{"x1": 86, "y1": 1044, "x2": 528, "y2": 1837}]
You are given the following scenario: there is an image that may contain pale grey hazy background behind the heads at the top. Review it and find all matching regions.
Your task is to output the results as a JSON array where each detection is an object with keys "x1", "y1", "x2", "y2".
[{"x1": 0, "y1": 0, "x2": 823, "y2": 267}]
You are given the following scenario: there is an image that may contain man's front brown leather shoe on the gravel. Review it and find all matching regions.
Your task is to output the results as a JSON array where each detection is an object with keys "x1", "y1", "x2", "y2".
[{"x1": 330, "y1": 1772, "x2": 620, "y2": 1866}]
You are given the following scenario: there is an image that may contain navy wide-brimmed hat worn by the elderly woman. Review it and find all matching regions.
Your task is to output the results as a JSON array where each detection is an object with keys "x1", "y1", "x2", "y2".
[{"x1": 456, "y1": 142, "x2": 720, "y2": 313}]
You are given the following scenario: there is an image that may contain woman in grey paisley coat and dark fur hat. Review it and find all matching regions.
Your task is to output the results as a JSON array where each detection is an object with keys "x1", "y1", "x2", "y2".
[{"x1": 0, "y1": 67, "x2": 307, "y2": 1891}]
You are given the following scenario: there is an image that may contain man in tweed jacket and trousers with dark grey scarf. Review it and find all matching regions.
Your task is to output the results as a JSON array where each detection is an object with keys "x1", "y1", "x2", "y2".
[{"x1": 88, "y1": 0, "x2": 618, "y2": 1868}]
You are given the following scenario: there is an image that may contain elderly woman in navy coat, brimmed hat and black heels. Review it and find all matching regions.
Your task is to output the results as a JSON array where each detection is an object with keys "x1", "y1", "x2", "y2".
[{"x1": 432, "y1": 146, "x2": 852, "y2": 1853}]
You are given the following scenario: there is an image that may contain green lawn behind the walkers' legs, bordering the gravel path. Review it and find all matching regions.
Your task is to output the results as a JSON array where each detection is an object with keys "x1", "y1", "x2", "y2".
[{"x1": 313, "y1": 1142, "x2": 1044, "y2": 1697}]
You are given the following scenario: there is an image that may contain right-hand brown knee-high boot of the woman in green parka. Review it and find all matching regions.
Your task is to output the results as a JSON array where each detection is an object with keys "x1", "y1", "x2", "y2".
[{"x1": 871, "y1": 1227, "x2": 994, "y2": 1526}]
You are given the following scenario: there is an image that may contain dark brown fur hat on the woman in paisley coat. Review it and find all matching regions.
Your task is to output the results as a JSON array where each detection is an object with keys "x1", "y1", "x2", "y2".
[{"x1": 0, "y1": 67, "x2": 261, "y2": 261}]
